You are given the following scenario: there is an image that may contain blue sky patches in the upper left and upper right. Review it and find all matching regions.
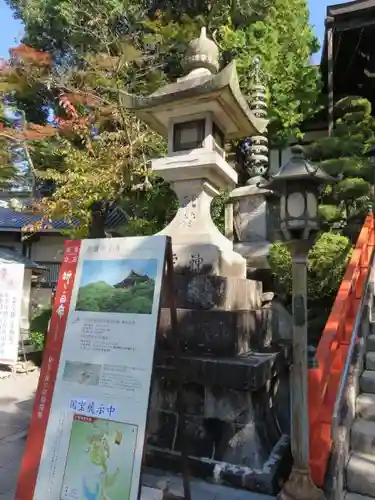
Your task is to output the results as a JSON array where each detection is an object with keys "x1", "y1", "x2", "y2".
[{"x1": 0, "y1": 0, "x2": 347, "y2": 63}]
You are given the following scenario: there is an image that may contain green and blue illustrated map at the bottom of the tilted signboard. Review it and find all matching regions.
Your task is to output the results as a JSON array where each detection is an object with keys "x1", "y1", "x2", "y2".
[{"x1": 61, "y1": 415, "x2": 138, "y2": 500}]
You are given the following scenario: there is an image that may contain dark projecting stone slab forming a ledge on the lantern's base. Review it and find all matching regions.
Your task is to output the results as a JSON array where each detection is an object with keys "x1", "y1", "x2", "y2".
[{"x1": 156, "y1": 350, "x2": 287, "y2": 391}]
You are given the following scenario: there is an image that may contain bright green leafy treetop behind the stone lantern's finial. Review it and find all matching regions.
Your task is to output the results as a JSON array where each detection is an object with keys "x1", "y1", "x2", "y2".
[{"x1": 146, "y1": 0, "x2": 320, "y2": 144}]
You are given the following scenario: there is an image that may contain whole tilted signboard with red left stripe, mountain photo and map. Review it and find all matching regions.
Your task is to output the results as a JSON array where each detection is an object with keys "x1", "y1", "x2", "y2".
[{"x1": 15, "y1": 236, "x2": 167, "y2": 500}]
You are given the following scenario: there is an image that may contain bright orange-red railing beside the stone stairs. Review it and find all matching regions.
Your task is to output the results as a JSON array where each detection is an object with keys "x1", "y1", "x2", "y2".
[{"x1": 308, "y1": 214, "x2": 375, "y2": 486}]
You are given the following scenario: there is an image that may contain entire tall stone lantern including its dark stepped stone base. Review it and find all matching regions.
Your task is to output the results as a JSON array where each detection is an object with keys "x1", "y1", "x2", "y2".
[{"x1": 122, "y1": 29, "x2": 290, "y2": 500}]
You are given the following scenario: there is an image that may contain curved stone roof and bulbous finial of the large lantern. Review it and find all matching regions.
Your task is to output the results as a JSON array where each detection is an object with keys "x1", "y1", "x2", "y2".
[{"x1": 120, "y1": 28, "x2": 268, "y2": 139}]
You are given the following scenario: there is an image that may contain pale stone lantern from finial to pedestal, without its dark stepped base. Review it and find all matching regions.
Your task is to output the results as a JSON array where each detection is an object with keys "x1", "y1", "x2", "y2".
[{"x1": 121, "y1": 28, "x2": 267, "y2": 277}]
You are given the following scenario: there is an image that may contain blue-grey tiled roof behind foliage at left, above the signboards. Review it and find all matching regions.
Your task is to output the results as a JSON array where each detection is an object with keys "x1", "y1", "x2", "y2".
[{"x1": 0, "y1": 207, "x2": 126, "y2": 232}]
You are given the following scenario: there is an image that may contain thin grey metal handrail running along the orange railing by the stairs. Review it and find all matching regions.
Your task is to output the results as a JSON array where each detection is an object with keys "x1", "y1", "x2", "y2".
[{"x1": 331, "y1": 247, "x2": 375, "y2": 441}]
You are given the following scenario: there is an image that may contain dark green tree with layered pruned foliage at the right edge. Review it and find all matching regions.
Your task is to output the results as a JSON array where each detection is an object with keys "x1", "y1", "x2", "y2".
[{"x1": 307, "y1": 96, "x2": 375, "y2": 239}]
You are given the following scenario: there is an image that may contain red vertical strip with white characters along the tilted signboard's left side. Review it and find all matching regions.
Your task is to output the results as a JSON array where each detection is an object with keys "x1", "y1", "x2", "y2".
[{"x1": 15, "y1": 241, "x2": 81, "y2": 500}]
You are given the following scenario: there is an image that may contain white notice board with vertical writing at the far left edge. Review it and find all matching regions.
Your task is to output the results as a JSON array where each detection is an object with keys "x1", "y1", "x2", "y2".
[{"x1": 0, "y1": 263, "x2": 25, "y2": 365}]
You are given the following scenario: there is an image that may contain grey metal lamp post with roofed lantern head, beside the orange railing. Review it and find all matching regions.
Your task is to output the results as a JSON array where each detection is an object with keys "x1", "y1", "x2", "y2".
[{"x1": 262, "y1": 146, "x2": 334, "y2": 500}]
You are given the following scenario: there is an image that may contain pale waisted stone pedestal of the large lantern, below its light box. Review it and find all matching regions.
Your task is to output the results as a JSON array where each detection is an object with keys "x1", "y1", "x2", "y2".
[{"x1": 152, "y1": 150, "x2": 246, "y2": 278}]
